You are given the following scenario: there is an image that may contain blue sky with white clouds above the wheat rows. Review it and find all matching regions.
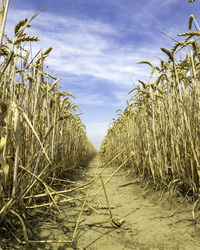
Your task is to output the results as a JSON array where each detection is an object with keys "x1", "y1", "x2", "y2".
[{"x1": 4, "y1": 0, "x2": 200, "y2": 149}]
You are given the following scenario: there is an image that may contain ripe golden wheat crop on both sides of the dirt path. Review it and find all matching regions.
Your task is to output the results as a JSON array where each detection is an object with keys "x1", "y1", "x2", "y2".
[{"x1": 0, "y1": 0, "x2": 200, "y2": 249}]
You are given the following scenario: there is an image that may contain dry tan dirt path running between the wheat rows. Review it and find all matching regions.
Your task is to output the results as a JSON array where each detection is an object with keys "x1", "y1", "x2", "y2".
[{"x1": 38, "y1": 157, "x2": 200, "y2": 250}]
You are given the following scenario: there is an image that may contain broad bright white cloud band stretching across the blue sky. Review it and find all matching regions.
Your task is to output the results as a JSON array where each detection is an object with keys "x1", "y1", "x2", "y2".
[{"x1": 5, "y1": 7, "x2": 167, "y2": 86}]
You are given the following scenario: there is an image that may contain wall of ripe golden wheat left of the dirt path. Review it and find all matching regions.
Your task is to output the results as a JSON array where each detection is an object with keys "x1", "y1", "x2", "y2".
[{"x1": 0, "y1": 3, "x2": 96, "y2": 248}]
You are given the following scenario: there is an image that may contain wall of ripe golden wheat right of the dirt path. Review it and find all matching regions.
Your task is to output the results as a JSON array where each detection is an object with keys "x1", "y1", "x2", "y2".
[{"x1": 101, "y1": 13, "x2": 200, "y2": 199}]
